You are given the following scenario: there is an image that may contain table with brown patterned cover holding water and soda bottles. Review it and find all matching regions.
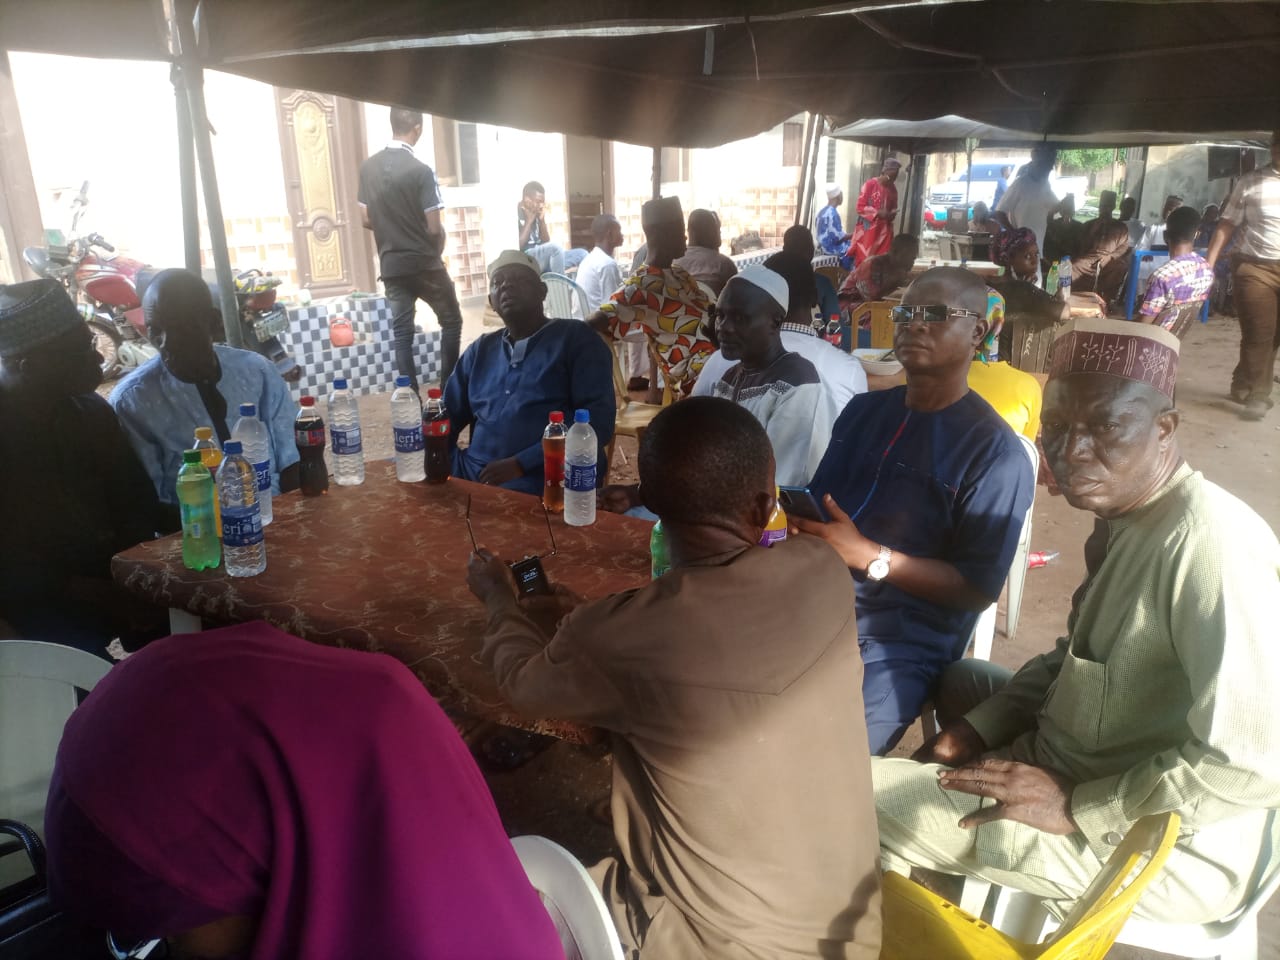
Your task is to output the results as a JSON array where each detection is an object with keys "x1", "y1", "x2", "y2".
[{"x1": 111, "y1": 471, "x2": 652, "y2": 740}]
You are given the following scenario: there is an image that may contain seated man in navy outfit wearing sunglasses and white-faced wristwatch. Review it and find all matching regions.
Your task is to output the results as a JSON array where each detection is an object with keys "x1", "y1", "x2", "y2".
[{"x1": 794, "y1": 268, "x2": 1036, "y2": 754}]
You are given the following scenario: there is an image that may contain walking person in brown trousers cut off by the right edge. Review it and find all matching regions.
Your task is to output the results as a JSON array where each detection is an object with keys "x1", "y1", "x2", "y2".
[{"x1": 1207, "y1": 131, "x2": 1280, "y2": 420}]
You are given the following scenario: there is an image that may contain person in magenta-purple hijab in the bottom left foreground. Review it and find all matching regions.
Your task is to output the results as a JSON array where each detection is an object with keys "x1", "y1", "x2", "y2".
[{"x1": 45, "y1": 623, "x2": 563, "y2": 960}]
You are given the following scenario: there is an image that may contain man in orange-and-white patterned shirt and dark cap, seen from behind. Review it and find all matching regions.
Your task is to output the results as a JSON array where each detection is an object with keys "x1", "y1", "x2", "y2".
[{"x1": 590, "y1": 197, "x2": 714, "y2": 403}]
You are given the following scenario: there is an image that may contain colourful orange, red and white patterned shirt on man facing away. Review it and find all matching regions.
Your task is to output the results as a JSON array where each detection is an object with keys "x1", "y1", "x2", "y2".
[{"x1": 600, "y1": 265, "x2": 716, "y2": 381}]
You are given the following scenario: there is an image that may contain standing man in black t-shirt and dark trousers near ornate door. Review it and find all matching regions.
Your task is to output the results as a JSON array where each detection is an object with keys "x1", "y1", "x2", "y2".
[{"x1": 358, "y1": 106, "x2": 462, "y2": 390}]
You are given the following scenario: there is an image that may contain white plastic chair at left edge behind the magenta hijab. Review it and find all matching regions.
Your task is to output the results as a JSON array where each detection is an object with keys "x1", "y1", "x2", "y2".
[{"x1": 0, "y1": 640, "x2": 111, "y2": 884}]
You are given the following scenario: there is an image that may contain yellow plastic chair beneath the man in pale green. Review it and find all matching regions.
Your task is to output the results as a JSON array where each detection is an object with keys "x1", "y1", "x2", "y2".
[{"x1": 881, "y1": 813, "x2": 1179, "y2": 960}]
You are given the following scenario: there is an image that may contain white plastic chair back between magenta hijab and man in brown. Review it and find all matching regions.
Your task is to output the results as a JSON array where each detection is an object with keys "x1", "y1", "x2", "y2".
[{"x1": 511, "y1": 837, "x2": 622, "y2": 960}]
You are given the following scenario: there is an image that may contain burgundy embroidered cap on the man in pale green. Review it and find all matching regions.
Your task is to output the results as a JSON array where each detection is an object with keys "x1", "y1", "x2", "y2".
[{"x1": 1048, "y1": 319, "x2": 1179, "y2": 399}]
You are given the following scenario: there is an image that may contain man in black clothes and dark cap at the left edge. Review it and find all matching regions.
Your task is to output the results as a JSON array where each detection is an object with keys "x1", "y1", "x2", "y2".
[{"x1": 0, "y1": 280, "x2": 162, "y2": 655}]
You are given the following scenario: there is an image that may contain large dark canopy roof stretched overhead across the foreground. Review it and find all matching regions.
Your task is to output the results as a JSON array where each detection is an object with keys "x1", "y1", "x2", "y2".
[{"x1": 0, "y1": 0, "x2": 1280, "y2": 147}]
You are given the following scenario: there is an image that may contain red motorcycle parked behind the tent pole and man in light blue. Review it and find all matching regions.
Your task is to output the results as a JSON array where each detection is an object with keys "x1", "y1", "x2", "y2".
[{"x1": 22, "y1": 180, "x2": 302, "y2": 380}]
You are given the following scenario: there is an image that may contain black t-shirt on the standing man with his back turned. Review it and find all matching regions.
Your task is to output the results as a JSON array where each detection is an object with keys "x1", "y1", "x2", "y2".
[{"x1": 360, "y1": 146, "x2": 444, "y2": 278}]
